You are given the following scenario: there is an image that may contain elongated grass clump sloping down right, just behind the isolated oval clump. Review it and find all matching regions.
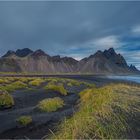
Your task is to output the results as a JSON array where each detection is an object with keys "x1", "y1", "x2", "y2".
[{"x1": 44, "y1": 84, "x2": 68, "y2": 95}]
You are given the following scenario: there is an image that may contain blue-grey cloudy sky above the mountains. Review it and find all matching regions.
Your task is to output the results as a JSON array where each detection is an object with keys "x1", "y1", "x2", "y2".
[{"x1": 0, "y1": 1, "x2": 140, "y2": 69}]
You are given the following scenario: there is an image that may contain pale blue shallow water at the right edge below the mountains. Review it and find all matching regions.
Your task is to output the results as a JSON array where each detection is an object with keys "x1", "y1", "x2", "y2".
[{"x1": 107, "y1": 75, "x2": 140, "y2": 83}]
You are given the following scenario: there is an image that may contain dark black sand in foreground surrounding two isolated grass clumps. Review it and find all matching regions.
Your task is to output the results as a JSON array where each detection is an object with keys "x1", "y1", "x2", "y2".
[{"x1": 0, "y1": 89, "x2": 79, "y2": 139}]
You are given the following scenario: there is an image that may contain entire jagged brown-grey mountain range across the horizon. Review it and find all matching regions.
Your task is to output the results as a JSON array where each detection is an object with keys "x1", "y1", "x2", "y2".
[{"x1": 0, "y1": 48, "x2": 140, "y2": 74}]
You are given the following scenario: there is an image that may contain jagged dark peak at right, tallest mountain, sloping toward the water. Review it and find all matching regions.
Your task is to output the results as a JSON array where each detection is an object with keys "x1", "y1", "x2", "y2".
[{"x1": 77, "y1": 48, "x2": 139, "y2": 74}]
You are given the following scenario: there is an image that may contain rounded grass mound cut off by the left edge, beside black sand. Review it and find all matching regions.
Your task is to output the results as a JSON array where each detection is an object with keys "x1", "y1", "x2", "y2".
[{"x1": 0, "y1": 91, "x2": 14, "y2": 109}]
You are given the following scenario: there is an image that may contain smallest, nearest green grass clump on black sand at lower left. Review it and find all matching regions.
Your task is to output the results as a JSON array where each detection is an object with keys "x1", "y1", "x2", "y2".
[{"x1": 16, "y1": 116, "x2": 32, "y2": 126}]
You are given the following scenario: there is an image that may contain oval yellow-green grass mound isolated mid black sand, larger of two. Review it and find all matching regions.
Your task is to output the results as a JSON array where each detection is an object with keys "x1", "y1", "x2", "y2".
[{"x1": 37, "y1": 97, "x2": 64, "y2": 112}]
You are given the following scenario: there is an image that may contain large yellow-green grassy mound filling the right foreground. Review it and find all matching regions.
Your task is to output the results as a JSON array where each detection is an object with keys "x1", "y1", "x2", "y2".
[{"x1": 51, "y1": 84, "x2": 140, "y2": 139}]
